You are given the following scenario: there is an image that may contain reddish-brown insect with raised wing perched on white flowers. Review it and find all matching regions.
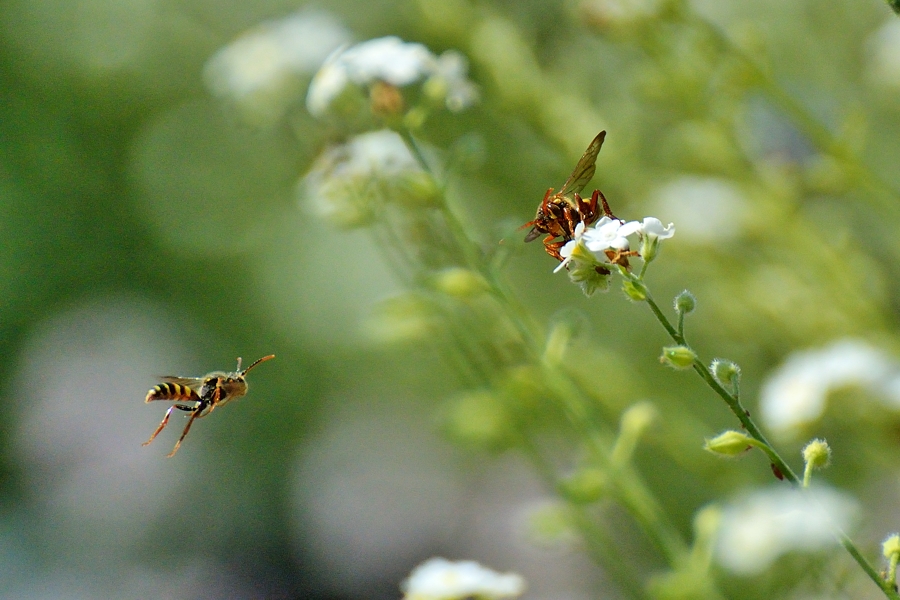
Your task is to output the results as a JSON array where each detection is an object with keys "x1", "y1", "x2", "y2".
[{"x1": 520, "y1": 131, "x2": 615, "y2": 261}]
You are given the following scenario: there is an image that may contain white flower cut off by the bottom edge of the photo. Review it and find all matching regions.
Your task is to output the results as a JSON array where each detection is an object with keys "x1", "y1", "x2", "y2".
[{"x1": 401, "y1": 558, "x2": 525, "y2": 600}]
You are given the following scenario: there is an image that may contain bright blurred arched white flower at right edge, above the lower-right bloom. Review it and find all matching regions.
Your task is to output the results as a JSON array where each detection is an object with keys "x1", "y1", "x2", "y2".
[{"x1": 760, "y1": 339, "x2": 900, "y2": 435}]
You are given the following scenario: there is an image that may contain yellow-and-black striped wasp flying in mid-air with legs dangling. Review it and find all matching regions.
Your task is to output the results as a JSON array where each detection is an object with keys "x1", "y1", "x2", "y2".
[{"x1": 143, "y1": 354, "x2": 275, "y2": 457}]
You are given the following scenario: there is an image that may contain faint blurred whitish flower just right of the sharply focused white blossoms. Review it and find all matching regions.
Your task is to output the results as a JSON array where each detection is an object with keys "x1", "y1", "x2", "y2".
[{"x1": 652, "y1": 176, "x2": 749, "y2": 243}]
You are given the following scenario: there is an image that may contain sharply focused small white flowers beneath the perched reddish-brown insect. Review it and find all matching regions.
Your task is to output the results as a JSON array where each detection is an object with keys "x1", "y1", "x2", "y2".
[{"x1": 553, "y1": 217, "x2": 675, "y2": 273}]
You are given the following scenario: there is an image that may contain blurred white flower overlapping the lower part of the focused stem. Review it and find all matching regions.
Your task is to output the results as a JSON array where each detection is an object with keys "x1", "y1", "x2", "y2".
[{"x1": 715, "y1": 486, "x2": 858, "y2": 575}]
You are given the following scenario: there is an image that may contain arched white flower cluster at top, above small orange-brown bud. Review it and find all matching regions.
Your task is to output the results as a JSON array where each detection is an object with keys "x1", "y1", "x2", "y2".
[{"x1": 306, "y1": 36, "x2": 478, "y2": 117}]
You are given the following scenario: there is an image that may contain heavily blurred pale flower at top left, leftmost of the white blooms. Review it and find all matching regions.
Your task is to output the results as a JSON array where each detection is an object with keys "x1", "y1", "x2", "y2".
[{"x1": 203, "y1": 10, "x2": 351, "y2": 122}]
